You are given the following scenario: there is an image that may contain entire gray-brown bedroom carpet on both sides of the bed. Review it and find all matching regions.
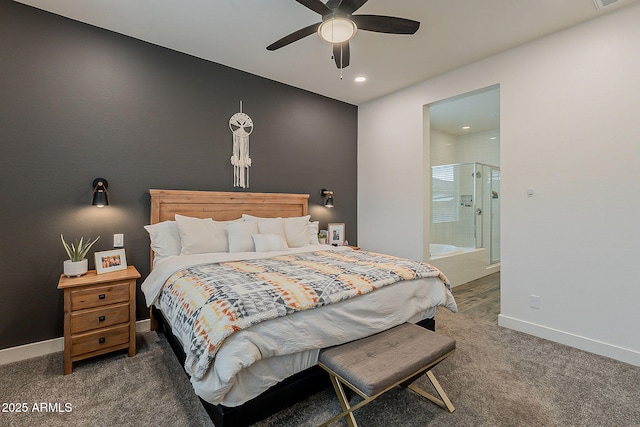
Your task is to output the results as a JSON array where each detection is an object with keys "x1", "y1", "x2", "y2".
[{"x1": 0, "y1": 310, "x2": 640, "y2": 427}]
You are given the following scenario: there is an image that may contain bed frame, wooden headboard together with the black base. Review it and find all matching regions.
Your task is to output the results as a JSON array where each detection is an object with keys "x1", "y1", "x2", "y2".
[{"x1": 149, "y1": 190, "x2": 435, "y2": 427}]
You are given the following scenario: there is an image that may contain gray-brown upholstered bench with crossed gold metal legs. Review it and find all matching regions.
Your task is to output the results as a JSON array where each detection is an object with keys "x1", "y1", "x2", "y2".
[{"x1": 318, "y1": 323, "x2": 456, "y2": 427}]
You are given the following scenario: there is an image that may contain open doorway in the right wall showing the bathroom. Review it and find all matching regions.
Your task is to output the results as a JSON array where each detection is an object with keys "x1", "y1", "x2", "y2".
[{"x1": 425, "y1": 85, "x2": 502, "y2": 286}]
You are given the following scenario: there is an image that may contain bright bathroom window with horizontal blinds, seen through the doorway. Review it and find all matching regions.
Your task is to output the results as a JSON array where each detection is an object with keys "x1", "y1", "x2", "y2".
[{"x1": 431, "y1": 165, "x2": 458, "y2": 224}]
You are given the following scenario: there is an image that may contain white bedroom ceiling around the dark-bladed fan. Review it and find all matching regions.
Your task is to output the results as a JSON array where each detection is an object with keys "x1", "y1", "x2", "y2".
[{"x1": 12, "y1": 0, "x2": 638, "y2": 105}]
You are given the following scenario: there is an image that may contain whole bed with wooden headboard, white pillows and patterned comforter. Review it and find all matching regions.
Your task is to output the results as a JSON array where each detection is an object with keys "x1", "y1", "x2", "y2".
[{"x1": 142, "y1": 190, "x2": 457, "y2": 427}]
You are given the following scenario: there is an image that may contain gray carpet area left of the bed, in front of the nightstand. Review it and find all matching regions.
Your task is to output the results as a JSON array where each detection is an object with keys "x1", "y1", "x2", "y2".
[{"x1": 0, "y1": 332, "x2": 212, "y2": 427}]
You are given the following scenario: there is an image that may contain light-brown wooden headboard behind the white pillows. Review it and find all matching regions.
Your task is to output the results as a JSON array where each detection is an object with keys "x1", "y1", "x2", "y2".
[{"x1": 149, "y1": 190, "x2": 309, "y2": 268}]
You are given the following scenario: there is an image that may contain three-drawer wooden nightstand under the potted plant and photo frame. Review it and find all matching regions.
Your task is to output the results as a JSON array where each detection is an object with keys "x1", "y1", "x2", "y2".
[{"x1": 58, "y1": 266, "x2": 140, "y2": 375}]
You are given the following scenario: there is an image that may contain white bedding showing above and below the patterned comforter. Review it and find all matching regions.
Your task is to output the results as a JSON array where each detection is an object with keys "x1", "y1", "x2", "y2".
[{"x1": 142, "y1": 245, "x2": 457, "y2": 406}]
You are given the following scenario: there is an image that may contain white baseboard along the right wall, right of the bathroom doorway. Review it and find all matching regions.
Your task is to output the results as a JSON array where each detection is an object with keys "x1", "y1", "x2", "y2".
[{"x1": 498, "y1": 314, "x2": 640, "y2": 366}]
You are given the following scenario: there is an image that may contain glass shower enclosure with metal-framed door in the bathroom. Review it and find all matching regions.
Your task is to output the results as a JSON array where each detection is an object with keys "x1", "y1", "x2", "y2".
[{"x1": 430, "y1": 162, "x2": 500, "y2": 265}]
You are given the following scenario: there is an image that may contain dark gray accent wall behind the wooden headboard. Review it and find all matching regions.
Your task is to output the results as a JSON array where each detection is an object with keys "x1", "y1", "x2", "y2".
[{"x1": 0, "y1": 0, "x2": 357, "y2": 348}]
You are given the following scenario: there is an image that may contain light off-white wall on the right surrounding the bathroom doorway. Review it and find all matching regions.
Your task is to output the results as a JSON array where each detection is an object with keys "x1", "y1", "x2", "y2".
[{"x1": 358, "y1": 4, "x2": 640, "y2": 365}]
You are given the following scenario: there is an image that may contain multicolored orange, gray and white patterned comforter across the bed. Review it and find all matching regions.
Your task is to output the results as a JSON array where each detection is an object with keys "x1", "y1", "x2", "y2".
[{"x1": 160, "y1": 250, "x2": 450, "y2": 379}]
